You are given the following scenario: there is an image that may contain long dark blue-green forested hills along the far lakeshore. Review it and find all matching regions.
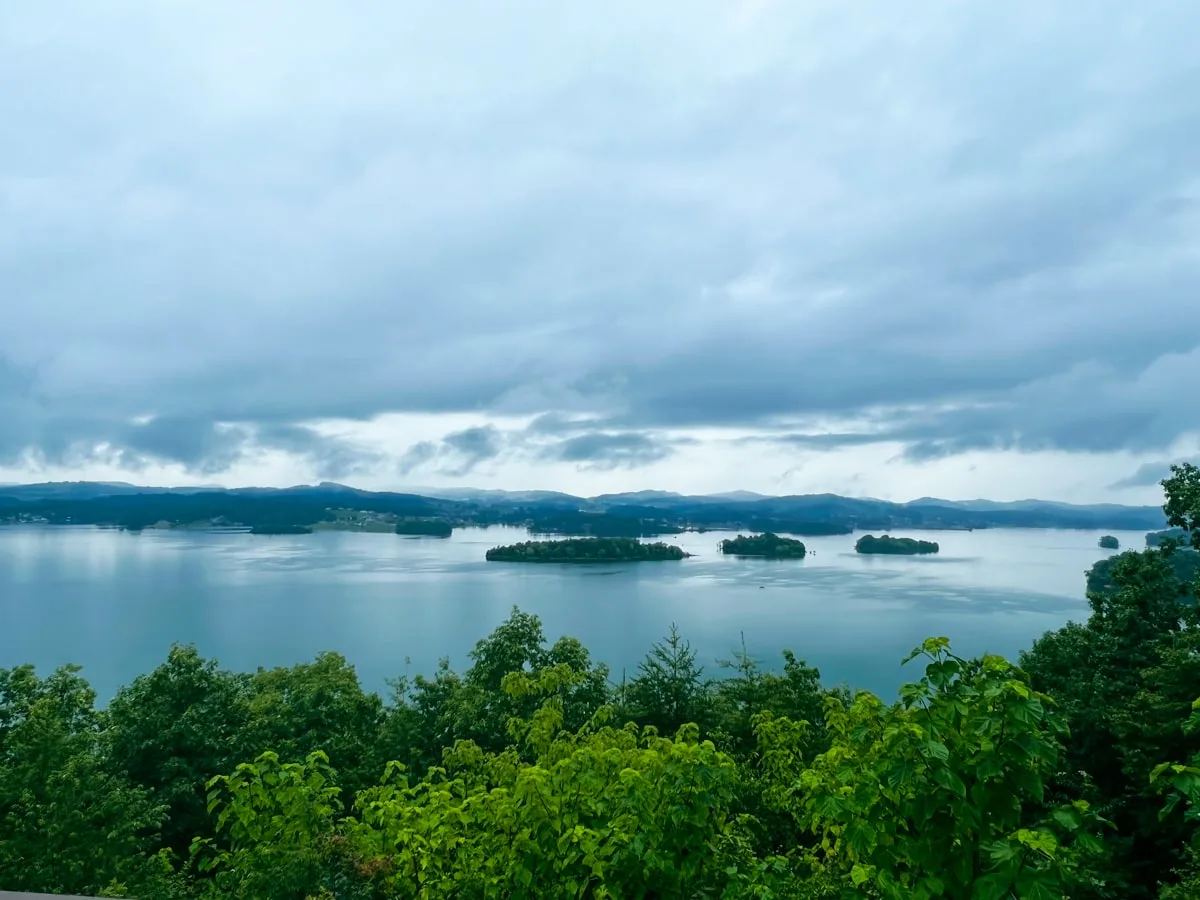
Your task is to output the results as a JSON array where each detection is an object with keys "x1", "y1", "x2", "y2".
[{"x1": 0, "y1": 481, "x2": 1166, "y2": 534}]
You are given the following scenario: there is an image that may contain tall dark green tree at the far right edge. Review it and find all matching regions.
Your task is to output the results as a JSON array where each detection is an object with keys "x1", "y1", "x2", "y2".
[{"x1": 1021, "y1": 467, "x2": 1200, "y2": 898}]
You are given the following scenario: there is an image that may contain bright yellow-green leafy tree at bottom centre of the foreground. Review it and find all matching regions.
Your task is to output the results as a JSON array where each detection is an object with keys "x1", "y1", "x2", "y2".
[{"x1": 352, "y1": 665, "x2": 736, "y2": 898}]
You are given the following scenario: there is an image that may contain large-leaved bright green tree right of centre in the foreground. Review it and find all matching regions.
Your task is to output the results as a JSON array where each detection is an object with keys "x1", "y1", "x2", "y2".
[{"x1": 760, "y1": 638, "x2": 1099, "y2": 900}]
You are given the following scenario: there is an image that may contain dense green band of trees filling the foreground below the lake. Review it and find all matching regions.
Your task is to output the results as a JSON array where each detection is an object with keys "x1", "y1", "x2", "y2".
[{"x1": 0, "y1": 467, "x2": 1200, "y2": 900}]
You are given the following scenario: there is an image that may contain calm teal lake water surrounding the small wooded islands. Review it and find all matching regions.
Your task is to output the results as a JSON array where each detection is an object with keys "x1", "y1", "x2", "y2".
[{"x1": 0, "y1": 527, "x2": 1144, "y2": 702}]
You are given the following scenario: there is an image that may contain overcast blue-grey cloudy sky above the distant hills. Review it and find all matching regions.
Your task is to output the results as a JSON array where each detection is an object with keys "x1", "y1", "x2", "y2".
[{"x1": 0, "y1": 0, "x2": 1200, "y2": 503}]
